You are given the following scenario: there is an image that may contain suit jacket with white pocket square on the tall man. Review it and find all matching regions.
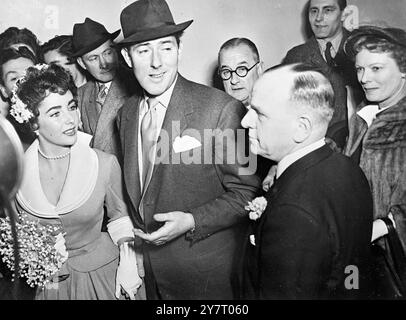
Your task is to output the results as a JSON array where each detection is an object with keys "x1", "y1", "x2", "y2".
[{"x1": 118, "y1": 75, "x2": 260, "y2": 299}]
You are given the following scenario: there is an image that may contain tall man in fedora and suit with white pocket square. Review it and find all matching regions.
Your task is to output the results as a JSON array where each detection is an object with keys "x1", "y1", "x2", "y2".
[{"x1": 117, "y1": 0, "x2": 260, "y2": 299}]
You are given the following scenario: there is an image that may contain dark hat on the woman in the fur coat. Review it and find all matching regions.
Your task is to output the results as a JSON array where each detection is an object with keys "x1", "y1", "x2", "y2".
[{"x1": 344, "y1": 26, "x2": 406, "y2": 59}]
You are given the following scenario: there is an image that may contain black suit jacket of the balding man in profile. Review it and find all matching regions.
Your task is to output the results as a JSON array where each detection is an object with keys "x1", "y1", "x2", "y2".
[{"x1": 245, "y1": 145, "x2": 372, "y2": 299}]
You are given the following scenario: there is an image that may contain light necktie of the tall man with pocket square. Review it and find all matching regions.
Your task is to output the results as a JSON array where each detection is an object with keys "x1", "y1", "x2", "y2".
[{"x1": 141, "y1": 98, "x2": 159, "y2": 190}]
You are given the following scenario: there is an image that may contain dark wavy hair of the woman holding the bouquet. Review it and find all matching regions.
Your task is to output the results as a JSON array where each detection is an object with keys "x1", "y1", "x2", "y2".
[{"x1": 16, "y1": 64, "x2": 77, "y2": 130}]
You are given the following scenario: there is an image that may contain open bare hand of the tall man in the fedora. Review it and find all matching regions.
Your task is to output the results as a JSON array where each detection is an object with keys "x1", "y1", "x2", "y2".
[{"x1": 134, "y1": 211, "x2": 195, "y2": 246}]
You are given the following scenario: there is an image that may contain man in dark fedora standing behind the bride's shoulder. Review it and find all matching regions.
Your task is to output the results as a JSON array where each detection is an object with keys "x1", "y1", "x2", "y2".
[{"x1": 72, "y1": 18, "x2": 134, "y2": 160}]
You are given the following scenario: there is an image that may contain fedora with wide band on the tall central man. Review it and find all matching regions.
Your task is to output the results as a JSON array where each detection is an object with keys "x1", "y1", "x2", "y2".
[{"x1": 118, "y1": 0, "x2": 193, "y2": 46}]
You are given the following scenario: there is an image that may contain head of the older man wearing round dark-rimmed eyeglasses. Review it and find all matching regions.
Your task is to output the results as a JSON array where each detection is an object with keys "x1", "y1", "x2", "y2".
[{"x1": 218, "y1": 38, "x2": 262, "y2": 108}]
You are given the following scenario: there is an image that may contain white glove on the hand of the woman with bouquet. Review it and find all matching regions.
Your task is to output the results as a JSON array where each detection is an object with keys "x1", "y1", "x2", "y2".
[{"x1": 116, "y1": 242, "x2": 142, "y2": 300}]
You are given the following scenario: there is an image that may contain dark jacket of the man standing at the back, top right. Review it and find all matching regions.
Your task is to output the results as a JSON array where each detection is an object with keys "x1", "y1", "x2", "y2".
[{"x1": 283, "y1": 29, "x2": 363, "y2": 148}]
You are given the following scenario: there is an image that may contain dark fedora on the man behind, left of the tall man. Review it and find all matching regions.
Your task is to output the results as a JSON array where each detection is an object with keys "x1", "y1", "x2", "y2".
[{"x1": 72, "y1": 18, "x2": 120, "y2": 58}]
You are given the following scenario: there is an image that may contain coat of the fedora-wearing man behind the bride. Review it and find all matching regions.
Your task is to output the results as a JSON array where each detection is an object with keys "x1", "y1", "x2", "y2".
[{"x1": 78, "y1": 68, "x2": 136, "y2": 160}]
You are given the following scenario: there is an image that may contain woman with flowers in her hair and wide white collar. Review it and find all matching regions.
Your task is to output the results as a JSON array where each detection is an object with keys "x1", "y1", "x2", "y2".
[{"x1": 10, "y1": 65, "x2": 142, "y2": 300}]
